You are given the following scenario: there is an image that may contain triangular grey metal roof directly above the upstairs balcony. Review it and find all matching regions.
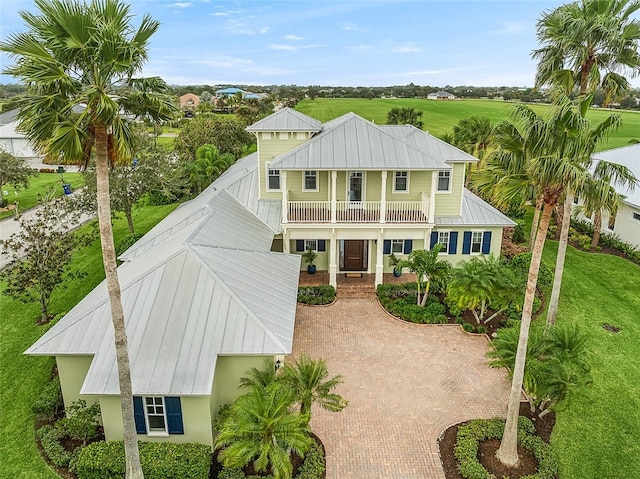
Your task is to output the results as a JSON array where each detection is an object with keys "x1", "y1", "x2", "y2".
[{"x1": 271, "y1": 113, "x2": 451, "y2": 170}]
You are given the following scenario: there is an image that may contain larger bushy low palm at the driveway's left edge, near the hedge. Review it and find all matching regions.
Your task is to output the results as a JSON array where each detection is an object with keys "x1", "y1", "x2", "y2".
[{"x1": 215, "y1": 382, "x2": 313, "y2": 479}]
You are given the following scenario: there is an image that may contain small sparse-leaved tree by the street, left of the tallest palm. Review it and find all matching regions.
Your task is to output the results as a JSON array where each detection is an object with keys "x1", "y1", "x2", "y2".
[{"x1": 0, "y1": 191, "x2": 92, "y2": 324}]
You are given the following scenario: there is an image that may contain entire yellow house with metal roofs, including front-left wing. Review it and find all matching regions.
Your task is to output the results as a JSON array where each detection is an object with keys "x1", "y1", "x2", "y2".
[{"x1": 26, "y1": 109, "x2": 513, "y2": 445}]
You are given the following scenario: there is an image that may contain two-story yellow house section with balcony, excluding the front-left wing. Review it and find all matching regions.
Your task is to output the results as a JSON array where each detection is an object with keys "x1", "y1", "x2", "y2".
[{"x1": 247, "y1": 108, "x2": 513, "y2": 286}]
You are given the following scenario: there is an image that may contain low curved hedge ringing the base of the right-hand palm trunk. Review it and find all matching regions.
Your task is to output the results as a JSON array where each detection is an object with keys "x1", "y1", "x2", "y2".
[{"x1": 454, "y1": 416, "x2": 558, "y2": 479}]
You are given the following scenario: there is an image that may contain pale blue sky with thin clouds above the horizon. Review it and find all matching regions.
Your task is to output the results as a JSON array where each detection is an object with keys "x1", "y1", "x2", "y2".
[{"x1": 0, "y1": 0, "x2": 640, "y2": 87}]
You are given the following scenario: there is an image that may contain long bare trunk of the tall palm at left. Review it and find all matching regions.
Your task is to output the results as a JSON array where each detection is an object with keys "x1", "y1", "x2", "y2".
[{"x1": 95, "y1": 125, "x2": 144, "y2": 479}]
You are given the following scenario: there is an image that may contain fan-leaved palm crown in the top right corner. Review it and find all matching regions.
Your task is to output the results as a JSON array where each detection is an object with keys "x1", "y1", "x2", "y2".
[{"x1": 532, "y1": 0, "x2": 640, "y2": 103}]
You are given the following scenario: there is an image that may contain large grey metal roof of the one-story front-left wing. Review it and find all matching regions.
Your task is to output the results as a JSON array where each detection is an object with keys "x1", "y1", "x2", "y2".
[{"x1": 26, "y1": 178, "x2": 300, "y2": 395}]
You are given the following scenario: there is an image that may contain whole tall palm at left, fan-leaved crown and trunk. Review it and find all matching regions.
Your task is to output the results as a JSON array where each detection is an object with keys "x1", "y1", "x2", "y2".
[{"x1": 0, "y1": 0, "x2": 175, "y2": 479}]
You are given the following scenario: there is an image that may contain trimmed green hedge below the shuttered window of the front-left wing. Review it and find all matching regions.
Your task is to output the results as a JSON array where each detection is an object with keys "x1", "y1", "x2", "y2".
[{"x1": 75, "y1": 441, "x2": 211, "y2": 479}]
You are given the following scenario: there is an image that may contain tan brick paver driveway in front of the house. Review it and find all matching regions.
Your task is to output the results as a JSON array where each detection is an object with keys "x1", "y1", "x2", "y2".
[{"x1": 294, "y1": 298, "x2": 509, "y2": 479}]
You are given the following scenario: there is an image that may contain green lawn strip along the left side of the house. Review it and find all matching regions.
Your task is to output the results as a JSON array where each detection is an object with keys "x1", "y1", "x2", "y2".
[{"x1": 0, "y1": 203, "x2": 177, "y2": 479}]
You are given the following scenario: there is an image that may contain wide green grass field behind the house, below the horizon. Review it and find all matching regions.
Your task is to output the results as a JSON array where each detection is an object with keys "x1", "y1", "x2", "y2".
[{"x1": 296, "y1": 98, "x2": 640, "y2": 150}]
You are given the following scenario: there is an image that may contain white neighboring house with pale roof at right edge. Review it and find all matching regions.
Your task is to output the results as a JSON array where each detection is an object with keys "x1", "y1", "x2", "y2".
[{"x1": 578, "y1": 143, "x2": 640, "y2": 248}]
